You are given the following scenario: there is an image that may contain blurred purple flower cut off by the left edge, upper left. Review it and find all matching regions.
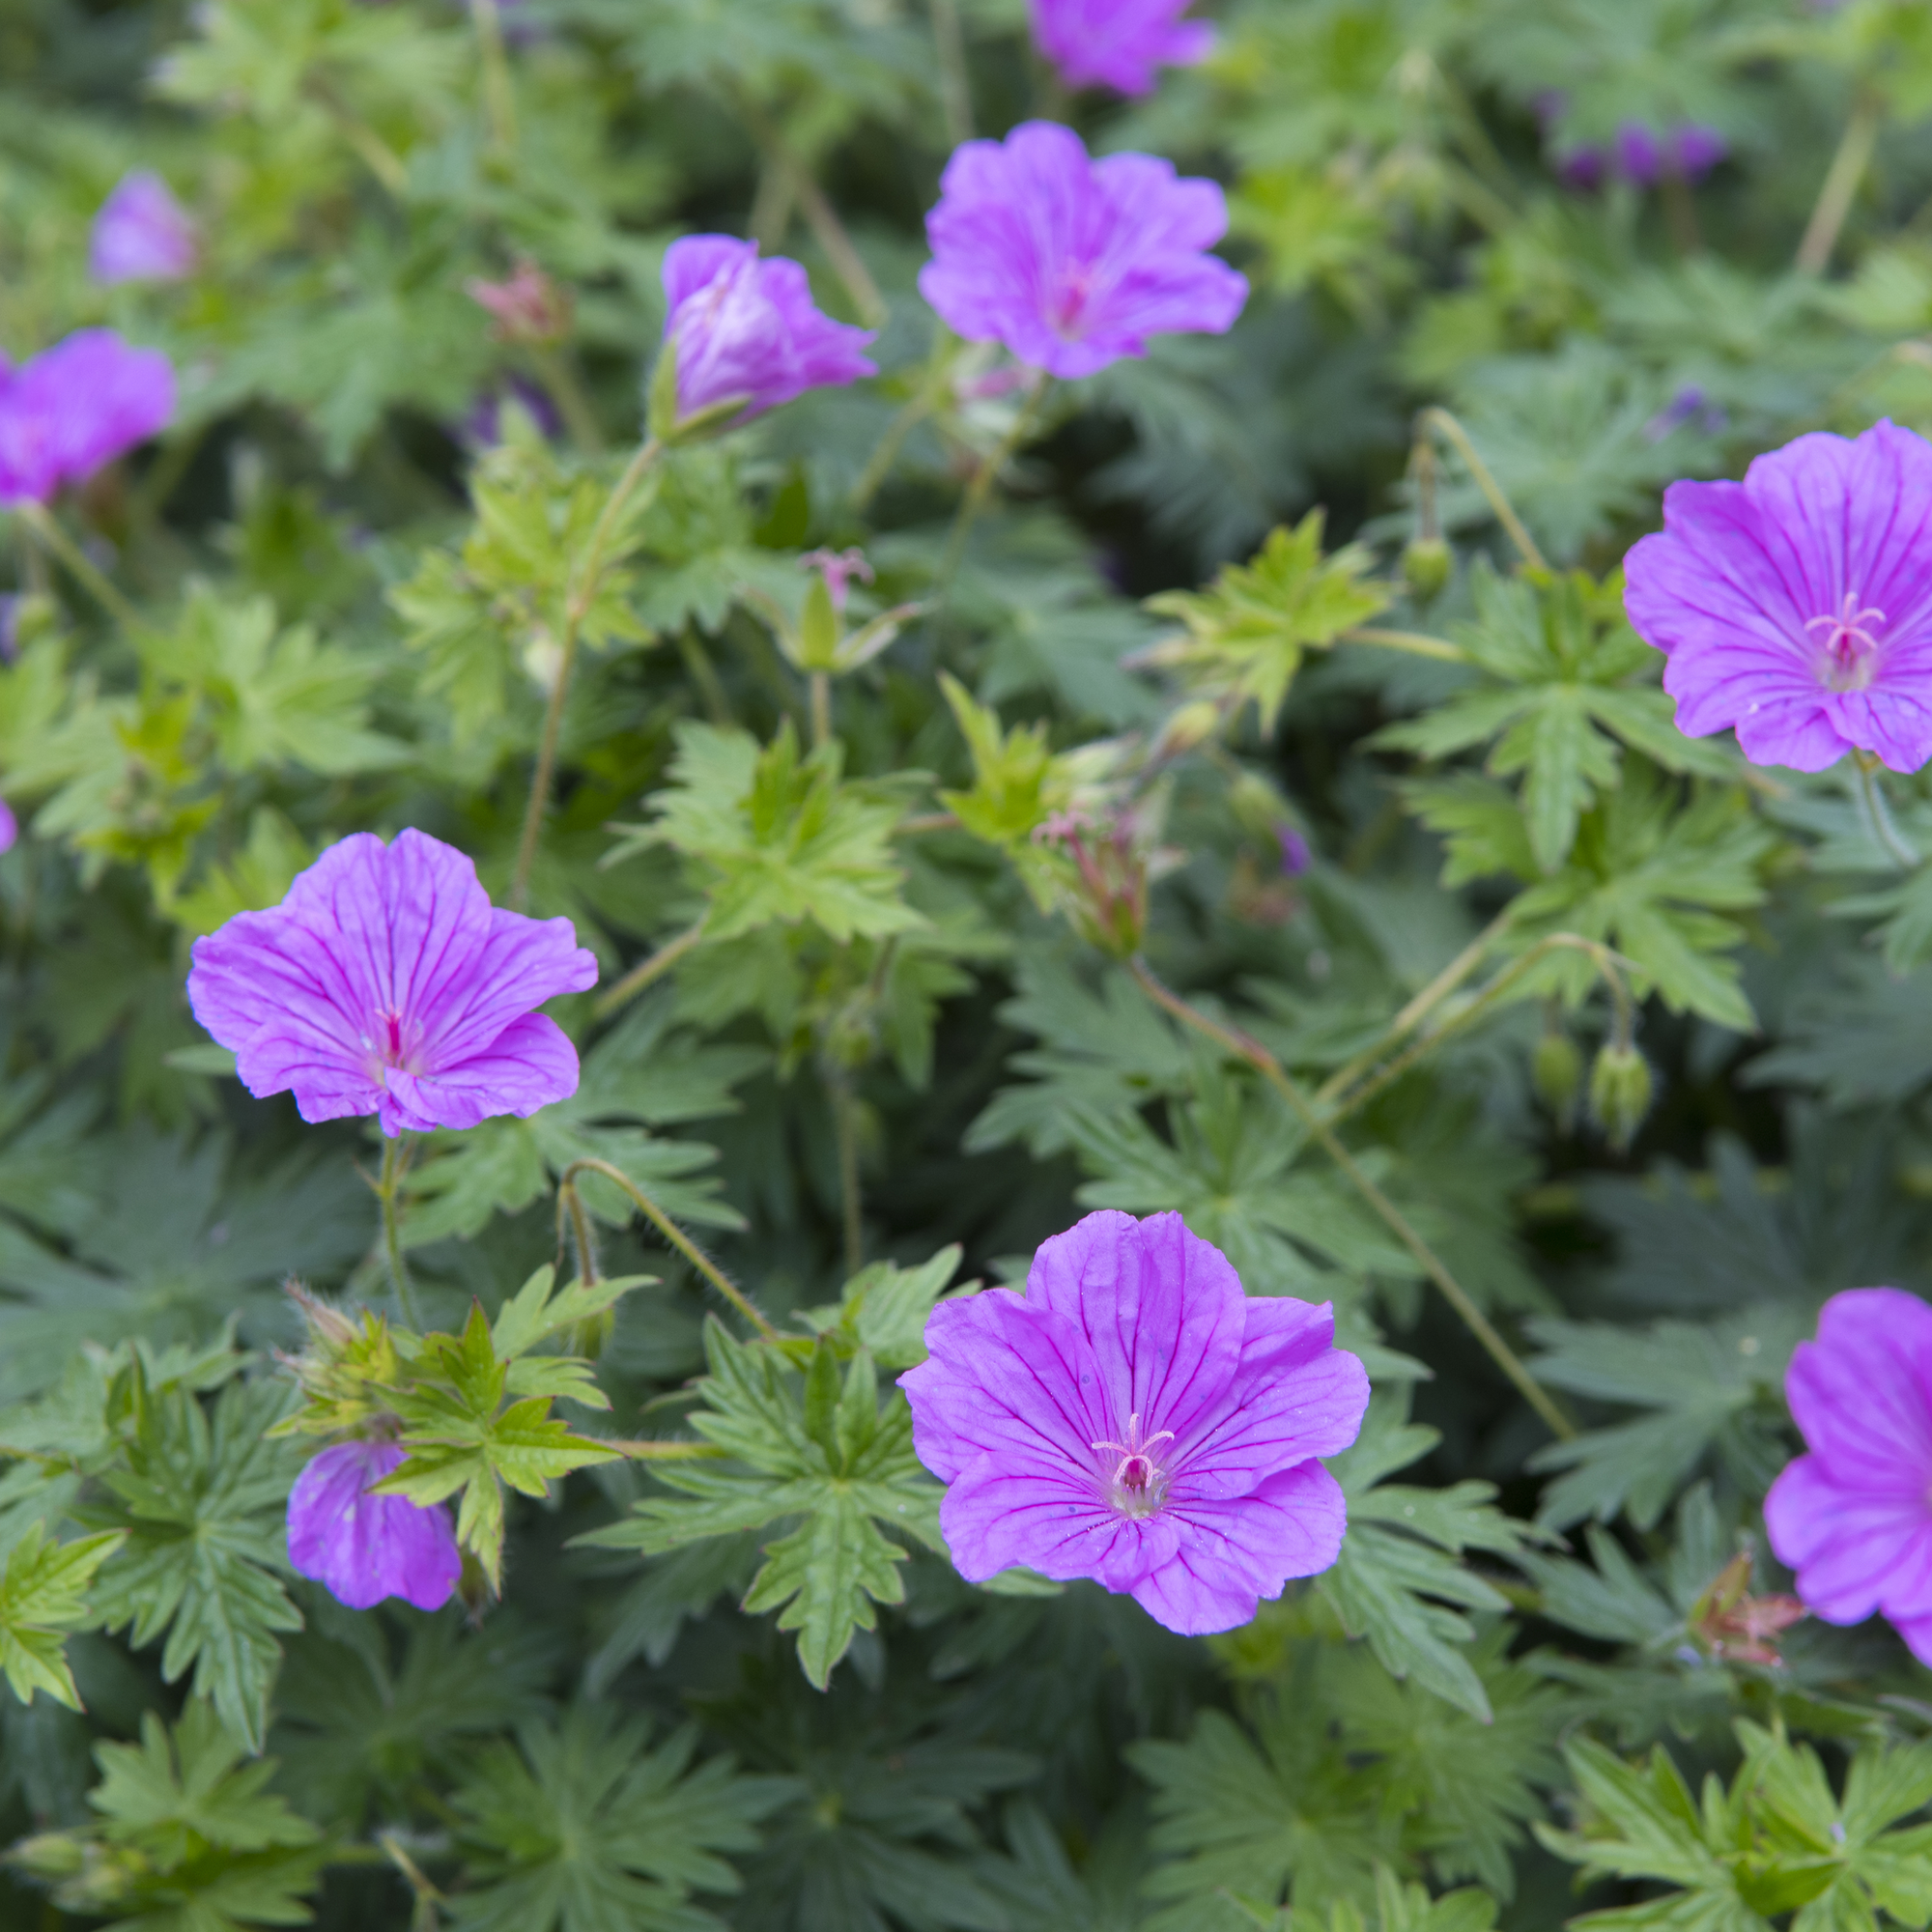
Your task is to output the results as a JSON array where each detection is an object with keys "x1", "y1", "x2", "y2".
[{"x1": 0, "y1": 328, "x2": 174, "y2": 506}]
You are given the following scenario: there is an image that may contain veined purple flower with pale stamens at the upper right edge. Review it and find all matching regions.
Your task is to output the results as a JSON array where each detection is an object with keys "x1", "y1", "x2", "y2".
[{"x1": 1623, "y1": 423, "x2": 1932, "y2": 771}]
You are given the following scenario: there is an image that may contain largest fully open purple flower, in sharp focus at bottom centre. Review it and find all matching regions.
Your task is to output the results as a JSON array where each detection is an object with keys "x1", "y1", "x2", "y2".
[{"x1": 900, "y1": 1211, "x2": 1368, "y2": 1636}]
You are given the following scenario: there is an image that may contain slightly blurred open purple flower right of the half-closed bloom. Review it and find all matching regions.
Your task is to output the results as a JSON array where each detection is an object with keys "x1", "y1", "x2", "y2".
[{"x1": 920, "y1": 122, "x2": 1248, "y2": 377}]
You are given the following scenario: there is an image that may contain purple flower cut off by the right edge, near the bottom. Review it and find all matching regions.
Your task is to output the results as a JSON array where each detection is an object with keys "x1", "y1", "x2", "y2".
[{"x1": 1764, "y1": 1289, "x2": 1932, "y2": 1663}]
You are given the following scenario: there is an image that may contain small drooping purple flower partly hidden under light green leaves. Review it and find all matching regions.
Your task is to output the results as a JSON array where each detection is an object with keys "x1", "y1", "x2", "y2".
[{"x1": 288, "y1": 1441, "x2": 464, "y2": 1609}]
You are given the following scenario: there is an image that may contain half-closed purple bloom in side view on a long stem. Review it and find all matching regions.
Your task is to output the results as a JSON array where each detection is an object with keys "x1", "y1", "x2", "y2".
[{"x1": 665, "y1": 236, "x2": 879, "y2": 421}]
